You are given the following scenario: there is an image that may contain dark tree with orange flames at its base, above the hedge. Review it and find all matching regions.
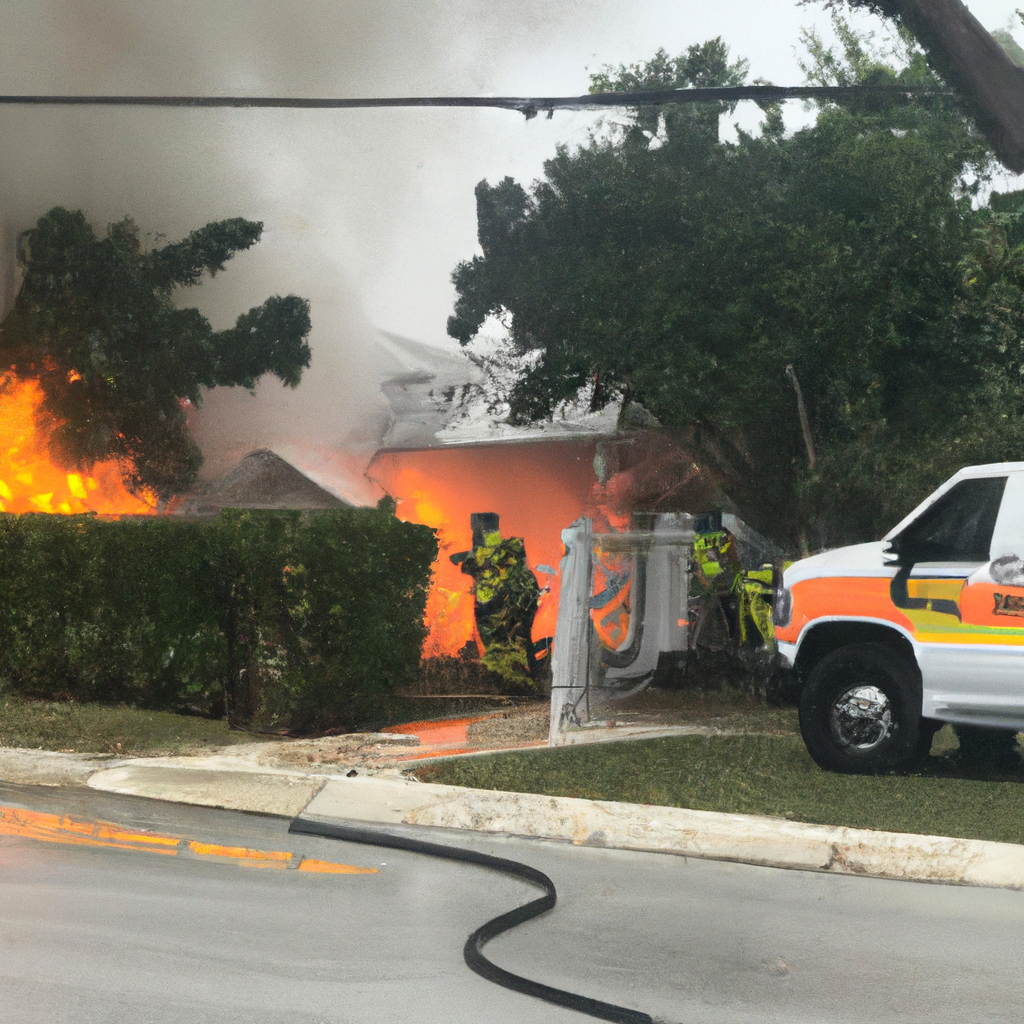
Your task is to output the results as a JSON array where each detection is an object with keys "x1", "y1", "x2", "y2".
[{"x1": 0, "y1": 207, "x2": 310, "y2": 498}]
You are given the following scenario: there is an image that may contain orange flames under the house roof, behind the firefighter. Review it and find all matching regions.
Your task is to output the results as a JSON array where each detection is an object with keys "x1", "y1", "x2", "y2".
[{"x1": 368, "y1": 440, "x2": 595, "y2": 657}]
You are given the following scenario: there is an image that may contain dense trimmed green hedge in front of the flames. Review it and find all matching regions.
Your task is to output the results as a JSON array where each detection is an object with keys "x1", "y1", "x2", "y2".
[{"x1": 0, "y1": 503, "x2": 437, "y2": 730}]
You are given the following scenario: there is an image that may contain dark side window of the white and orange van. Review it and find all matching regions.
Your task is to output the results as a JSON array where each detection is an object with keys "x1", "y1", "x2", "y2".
[{"x1": 891, "y1": 476, "x2": 1007, "y2": 564}]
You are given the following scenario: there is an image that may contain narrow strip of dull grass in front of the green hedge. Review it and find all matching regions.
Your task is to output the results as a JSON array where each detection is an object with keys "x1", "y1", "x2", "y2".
[{"x1": 0, "y1": 696, "x2": 270, "y2": 755}]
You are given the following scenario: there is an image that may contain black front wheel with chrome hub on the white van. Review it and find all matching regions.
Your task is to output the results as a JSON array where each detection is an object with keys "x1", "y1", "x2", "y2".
[{"x1": 800, "y1": 643, "x2": 922, "y2": 774}]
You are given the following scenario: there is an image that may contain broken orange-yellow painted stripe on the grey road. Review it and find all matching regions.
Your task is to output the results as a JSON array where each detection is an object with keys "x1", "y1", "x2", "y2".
[{"x1": 0, "y1": 807, "x2": 377, "y2": 874}]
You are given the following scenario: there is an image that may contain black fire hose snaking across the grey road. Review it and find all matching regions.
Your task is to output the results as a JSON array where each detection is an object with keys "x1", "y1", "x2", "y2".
[{"x1": 288, "y1": 817, "x2": 671, "y2": 1024}]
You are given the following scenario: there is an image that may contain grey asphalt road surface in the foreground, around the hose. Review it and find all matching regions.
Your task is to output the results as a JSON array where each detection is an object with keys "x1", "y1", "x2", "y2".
[{"x1": 0, "y1": 786, "x2": 1024, "y2": 1024}]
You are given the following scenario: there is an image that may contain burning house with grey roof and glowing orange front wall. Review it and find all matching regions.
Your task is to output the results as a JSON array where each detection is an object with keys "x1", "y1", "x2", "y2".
[{"x1": 367, "y1": 325, "x2": 745, "y2": 671}]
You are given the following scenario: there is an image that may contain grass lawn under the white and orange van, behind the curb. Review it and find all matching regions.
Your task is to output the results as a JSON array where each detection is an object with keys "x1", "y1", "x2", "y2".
[{"x1": 417, "y1": 727, "x2": 1024, "y2": 843}]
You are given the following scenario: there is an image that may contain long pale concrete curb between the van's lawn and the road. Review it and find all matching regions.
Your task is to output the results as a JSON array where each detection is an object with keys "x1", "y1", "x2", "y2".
[{"x1": 303, "y1": 778, "x2": 1024, "y2": 889}]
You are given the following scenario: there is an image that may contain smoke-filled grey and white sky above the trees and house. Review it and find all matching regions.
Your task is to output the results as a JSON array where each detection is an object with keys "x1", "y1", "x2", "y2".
[{"x1": 0, "y1": 0, "x2": 1024, "y2": 490}]
